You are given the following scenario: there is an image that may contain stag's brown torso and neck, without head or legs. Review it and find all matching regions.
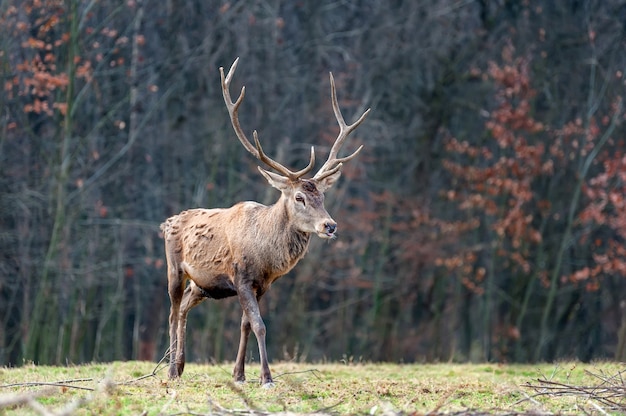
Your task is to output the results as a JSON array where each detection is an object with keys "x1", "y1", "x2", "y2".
[{"x1": 161, "y1": 201, "x2": 310, "y2": 299}]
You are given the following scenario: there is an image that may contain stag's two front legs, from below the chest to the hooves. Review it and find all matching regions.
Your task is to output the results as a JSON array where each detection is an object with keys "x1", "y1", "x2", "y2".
[{"x1": 233, "y1": 286, "x2": 274, "y2": 387}]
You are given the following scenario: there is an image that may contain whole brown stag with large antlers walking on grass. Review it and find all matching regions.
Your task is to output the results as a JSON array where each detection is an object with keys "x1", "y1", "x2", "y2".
[{"x1": 161, "y1": 58, "x2": 370, "y2": 387}]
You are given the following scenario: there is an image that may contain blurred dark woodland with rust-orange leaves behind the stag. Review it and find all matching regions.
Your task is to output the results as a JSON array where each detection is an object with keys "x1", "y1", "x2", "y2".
[{"x1": 0, "y1": 0, "x2": 626, "y2": 365}]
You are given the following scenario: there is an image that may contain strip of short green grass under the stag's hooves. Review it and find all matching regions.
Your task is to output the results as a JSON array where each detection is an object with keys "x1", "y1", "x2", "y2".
[{"x1": 0, "y1": 362, "x2": 626, "y2": 415}]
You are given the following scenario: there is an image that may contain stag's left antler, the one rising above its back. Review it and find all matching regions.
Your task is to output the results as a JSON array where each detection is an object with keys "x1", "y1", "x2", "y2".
[{"x1": 220, "y1": 58, "x2": 316, "y2": 181}]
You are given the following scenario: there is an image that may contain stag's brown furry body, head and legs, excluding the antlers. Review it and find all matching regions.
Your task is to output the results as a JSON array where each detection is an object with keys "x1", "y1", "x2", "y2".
[{"x1": 161, "y1": 177, "x2": 336, "y2": 384}]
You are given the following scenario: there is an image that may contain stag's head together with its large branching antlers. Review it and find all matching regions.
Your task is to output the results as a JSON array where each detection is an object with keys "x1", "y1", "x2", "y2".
[{"x1": 220, "y1": 58, "x2": 370, "y2": 238}]
